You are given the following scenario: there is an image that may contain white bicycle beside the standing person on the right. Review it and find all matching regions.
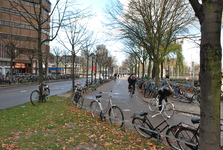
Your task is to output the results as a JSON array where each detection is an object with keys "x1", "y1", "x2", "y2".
[{"x1": 148, "y1": 93, "x2": 175, "y2": 118}]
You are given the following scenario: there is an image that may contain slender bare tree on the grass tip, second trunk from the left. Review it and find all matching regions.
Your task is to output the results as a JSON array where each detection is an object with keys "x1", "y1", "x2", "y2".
[{"x1": 58, "y1": 5, "x2": 91, "y2": 91}]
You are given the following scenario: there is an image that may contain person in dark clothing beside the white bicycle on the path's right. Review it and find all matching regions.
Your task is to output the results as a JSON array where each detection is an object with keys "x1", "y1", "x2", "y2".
[{"x1": 158, "y1": 75, "x2": 175, "y2": 111}]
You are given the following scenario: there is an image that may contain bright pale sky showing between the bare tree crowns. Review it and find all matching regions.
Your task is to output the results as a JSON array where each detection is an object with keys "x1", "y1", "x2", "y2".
[{"x1": 51, "y1": 0, "x2": 223, "y2": 65}]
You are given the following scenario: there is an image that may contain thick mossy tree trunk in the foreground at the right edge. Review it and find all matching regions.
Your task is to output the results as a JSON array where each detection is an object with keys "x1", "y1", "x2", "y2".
[{"x1": 190, "y1": 0, "x2": 223, "y2": 150}]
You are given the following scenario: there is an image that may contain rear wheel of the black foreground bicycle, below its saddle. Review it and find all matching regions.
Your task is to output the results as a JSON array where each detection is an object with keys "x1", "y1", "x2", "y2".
[{"x1": 132, "y1": 117, "x2": 153, "y2": 138}]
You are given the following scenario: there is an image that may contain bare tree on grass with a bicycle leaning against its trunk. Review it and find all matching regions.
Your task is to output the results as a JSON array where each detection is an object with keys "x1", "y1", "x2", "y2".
[{"x1": 10, "y1": 0, "x2": 68, "y2": 94}]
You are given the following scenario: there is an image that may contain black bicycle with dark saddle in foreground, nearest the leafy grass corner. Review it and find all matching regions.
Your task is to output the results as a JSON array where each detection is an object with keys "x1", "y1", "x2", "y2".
[{"x1": 131, "y1": 110, "x2": 178, "y2": 147}]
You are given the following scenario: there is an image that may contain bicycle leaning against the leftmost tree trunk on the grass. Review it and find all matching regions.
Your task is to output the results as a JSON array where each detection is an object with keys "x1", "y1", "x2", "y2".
[{"x1": 30, "y1": 84, "x2": 50, "y2": 106}]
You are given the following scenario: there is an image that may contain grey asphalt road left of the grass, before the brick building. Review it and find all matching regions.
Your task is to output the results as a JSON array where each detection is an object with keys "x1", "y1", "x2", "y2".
[{"x1": 0, "y1": 79, "x2": 85, "y2": 109}]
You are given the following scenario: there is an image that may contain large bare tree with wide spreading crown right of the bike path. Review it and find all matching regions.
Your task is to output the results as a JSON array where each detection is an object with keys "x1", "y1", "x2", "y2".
[{"x1": 106, "y1": 0, "x2": 194, "y2": 86}]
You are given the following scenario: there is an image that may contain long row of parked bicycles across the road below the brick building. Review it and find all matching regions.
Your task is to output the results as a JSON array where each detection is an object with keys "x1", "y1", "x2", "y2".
[{"x1": 0, "y1": 73, "x2": 79, "y2": 85}]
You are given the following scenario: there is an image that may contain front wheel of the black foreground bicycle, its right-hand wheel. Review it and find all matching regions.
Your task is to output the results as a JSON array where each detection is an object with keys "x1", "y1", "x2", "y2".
[{"x1": 166, "y1": 125, "x2": 180, "y2": 150}]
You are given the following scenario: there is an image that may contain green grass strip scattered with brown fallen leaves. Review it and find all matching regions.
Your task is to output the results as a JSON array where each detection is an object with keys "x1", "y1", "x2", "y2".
[{"x1": 0, "y1": 96, "x2": 167, "y2": 150}]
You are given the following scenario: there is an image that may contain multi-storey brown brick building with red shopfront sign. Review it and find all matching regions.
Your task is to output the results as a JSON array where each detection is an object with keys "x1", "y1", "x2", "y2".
[{"x1": 0, "y1": 0, "x2": 51, "y2": 75}]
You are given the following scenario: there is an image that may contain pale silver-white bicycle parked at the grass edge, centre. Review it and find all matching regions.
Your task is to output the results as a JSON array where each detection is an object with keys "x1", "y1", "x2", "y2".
[{"x1": 90, "y1": 91, "x2": 124, "y2": 127}]
